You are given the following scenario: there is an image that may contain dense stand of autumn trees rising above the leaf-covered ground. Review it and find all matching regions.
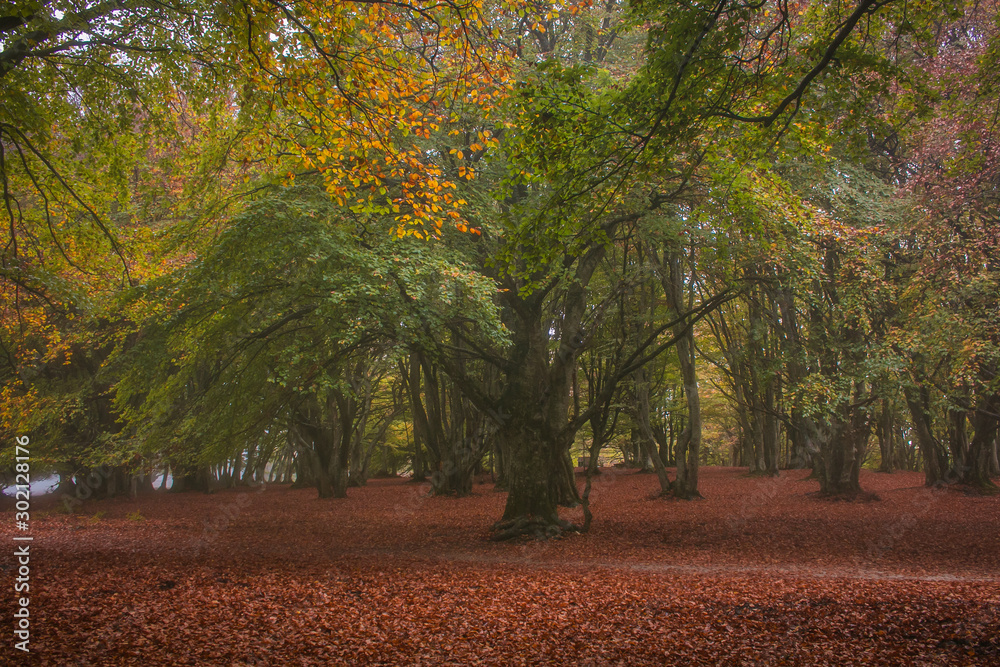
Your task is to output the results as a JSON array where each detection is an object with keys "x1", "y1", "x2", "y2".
[{"x1": 0, "y1": 0, "x2": 1000, "y2": 538}]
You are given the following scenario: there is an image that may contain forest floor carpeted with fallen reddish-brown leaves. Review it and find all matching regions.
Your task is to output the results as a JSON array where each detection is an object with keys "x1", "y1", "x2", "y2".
[{"x1": 0, "y1": 468, "x2": 1000, "y2": 667}]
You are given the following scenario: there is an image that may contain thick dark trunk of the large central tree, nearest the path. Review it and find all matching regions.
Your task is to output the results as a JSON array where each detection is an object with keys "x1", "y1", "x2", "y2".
[{"x1": 426, "y1": 243, "x2": 607, "y2": 539}]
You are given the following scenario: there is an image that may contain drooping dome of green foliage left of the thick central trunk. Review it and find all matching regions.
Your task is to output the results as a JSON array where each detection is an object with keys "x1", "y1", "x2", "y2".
[{"x1": 115, "y1": 186, "x2": 503, "y2": 461}]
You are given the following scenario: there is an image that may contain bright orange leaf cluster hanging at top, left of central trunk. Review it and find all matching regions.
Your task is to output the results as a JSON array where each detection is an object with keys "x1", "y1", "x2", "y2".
[{"x1": 222, "y1": 2, "x2": 510, "y2": 237}]
